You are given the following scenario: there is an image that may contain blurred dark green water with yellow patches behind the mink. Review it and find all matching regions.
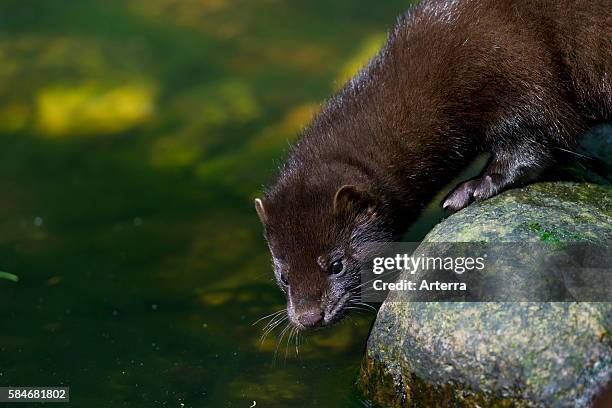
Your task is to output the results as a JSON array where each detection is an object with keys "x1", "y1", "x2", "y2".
[{"x1": 0, "y1": 0, "x2": 450, "y2": 407}]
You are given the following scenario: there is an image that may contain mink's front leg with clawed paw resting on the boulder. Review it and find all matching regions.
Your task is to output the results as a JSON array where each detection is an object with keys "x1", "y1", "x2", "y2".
[{"x1": 442, "y1": 144, "x2": 552, "y2": 211}]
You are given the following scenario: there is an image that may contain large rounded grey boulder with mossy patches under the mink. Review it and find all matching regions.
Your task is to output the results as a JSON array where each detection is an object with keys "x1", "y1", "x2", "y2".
[{"x1": 358, "y1": 183, "x2": 612, "y2": 407}]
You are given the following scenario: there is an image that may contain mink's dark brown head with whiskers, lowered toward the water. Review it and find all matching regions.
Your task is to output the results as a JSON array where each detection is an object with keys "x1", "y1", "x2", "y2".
[{"x1": 255, "y1": 180, "x2": 392, "y2": 329}]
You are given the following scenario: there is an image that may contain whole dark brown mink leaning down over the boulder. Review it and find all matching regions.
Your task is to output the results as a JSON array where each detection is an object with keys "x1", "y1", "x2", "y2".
[{"x1": 255, "y1": 0, "x2": 612, "y2": 329}]
